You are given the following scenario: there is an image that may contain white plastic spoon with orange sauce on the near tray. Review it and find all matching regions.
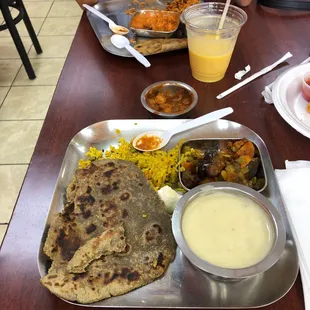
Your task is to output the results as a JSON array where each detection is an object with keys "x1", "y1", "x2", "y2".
[{"x1": 132, "y1": 108, "x2": 234, "y2": 152}]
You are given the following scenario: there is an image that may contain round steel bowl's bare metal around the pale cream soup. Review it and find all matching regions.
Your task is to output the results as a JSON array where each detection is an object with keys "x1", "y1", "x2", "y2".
[{"x1": 172, "y1": 182, "x2": 286, "y2": 280}]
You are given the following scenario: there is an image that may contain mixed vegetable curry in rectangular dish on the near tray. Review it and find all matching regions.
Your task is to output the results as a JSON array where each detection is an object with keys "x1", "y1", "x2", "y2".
[{"x1": 181, "y1": 139, "x2": 265, "y2": 190}]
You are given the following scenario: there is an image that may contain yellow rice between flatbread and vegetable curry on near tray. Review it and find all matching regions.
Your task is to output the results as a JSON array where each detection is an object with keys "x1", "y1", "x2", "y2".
[{"x1": 79, "y1": 138, "x2": 184, "y2": 190}]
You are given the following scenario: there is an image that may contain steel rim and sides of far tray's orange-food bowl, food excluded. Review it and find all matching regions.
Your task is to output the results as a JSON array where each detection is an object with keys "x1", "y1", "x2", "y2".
[{"x1": 129, "y1": 10, "x2": 180, "y2": 38}]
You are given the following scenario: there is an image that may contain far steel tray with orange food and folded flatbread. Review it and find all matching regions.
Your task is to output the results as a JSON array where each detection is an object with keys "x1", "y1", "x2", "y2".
[{"x1": 87, "y1": 0, "x2": 200, "y2": 57}]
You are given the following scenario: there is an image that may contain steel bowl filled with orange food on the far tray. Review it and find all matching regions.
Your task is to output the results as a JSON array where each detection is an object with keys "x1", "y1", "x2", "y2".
[{"x1": 129, "y1": 10, "x2": 180, "y2": 38}]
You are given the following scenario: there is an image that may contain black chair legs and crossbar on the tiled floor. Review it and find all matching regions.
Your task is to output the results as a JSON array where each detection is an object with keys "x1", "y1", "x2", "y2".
[{"x1": 0, "y1": 0, "x2": 42, "y2": 80}]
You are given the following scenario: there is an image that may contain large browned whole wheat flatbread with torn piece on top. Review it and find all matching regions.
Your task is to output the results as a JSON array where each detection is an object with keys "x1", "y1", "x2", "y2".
[{"x1": 41, "y1": 160, "x2": 176, "y2": 303}]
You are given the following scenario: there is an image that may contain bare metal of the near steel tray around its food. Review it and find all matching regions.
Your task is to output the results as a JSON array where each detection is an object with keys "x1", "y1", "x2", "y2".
[{"x1": 38, "y1": 119, "x2": 299, "y2": 309}]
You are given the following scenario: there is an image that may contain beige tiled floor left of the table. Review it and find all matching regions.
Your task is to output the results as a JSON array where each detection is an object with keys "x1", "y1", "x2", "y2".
[{"x1": 0, "y1": 0, "x2": 82, "y2": 245}]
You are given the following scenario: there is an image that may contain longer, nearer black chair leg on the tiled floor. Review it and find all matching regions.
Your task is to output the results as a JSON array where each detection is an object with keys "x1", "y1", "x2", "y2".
[{"x1": 0, "y1": 2, "x2": 36, "y2": 80}]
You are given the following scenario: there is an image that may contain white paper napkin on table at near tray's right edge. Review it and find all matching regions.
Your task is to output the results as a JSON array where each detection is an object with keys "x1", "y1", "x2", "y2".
[{"x1": 275, "y1": 160, "x2": 310, "y2": 310}]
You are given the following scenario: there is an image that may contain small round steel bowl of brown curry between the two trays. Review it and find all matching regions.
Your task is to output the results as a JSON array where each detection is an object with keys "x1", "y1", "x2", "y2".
[{"x1": 141, "y1": 81, "x2": 198, "y2": 118}]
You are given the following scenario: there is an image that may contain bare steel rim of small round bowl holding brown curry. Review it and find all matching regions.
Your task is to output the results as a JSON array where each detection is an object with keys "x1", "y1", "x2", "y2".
[{"x1": 141, "y1": 81, "x2": 198, "y2": 118}]
